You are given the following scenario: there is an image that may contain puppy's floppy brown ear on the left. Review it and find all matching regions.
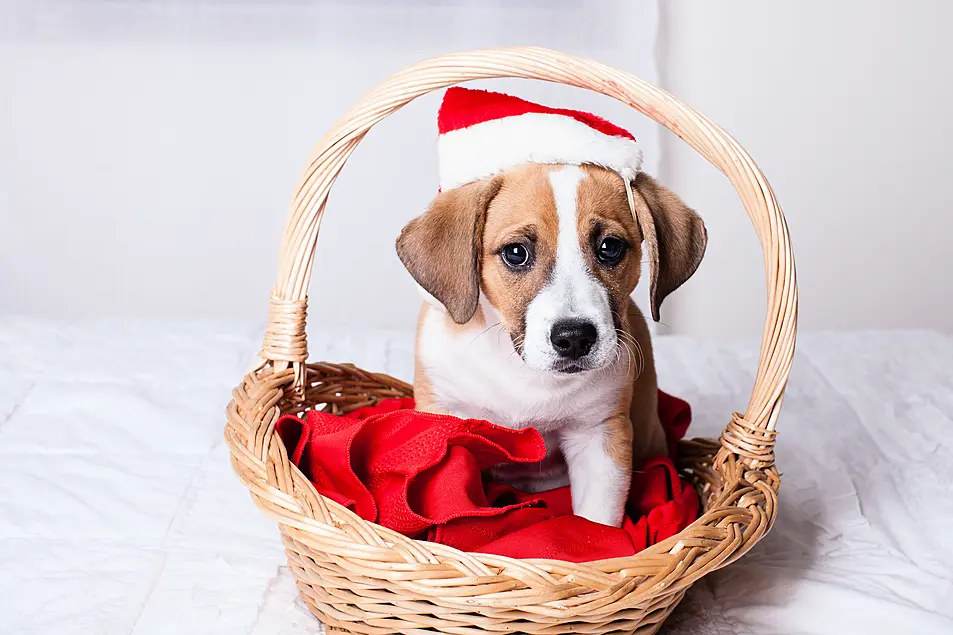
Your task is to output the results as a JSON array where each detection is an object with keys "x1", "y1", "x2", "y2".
[{"x1": 397, "y1": 177, "x2": 503, "y2": 324}]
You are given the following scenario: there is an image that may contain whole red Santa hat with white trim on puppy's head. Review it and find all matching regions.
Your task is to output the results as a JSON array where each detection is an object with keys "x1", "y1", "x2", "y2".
[{"x1": 437, "y1": 87, "x2": 642, "y2": 190}]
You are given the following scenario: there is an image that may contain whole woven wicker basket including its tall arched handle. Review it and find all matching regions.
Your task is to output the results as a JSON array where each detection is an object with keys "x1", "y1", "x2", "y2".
[{"x1": 225, "y1": 48, "x2": 797, "y2": 635}]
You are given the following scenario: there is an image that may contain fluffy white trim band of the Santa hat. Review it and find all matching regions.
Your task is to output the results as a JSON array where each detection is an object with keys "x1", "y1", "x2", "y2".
[{"x1": 437, "y1": 113, "x2": 642, "y2": 190}]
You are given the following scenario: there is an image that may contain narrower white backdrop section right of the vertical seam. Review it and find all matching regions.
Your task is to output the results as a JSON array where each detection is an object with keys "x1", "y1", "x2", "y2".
[{"x1": 659, "y1": 0, "x2": 953, "y2": 336}]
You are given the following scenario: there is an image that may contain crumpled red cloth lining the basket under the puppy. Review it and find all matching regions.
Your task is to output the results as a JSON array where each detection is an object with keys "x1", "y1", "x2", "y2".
[{"x1": 276, "y1": 392, "x2": 698, "y2": 562}]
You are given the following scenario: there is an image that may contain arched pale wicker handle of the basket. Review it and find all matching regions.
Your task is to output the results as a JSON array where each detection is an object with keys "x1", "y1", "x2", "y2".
[{"x1": 261, "y1": 48, "x2": 797, "y2": 466}]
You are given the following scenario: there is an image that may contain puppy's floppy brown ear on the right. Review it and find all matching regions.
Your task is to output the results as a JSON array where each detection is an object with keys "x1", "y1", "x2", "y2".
[{"x1": 633, "y1": 173, "x2": 708, "y2": 322}]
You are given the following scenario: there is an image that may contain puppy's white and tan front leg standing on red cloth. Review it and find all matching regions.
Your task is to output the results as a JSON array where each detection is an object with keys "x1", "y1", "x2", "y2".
[{"x1": 561, "y1": 416, "x2": 632, "y2": 527}]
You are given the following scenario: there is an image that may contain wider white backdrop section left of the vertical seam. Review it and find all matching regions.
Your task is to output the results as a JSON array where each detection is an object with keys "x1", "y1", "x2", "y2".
[{"x1": 0, "y1": 0, "x2": 658, "y2": 336}]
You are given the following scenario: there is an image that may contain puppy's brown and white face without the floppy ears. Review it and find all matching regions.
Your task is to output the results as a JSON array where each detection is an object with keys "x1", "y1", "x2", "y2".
[{"x1": 480, "y1": 165, "x2": 642, "y2": 373}]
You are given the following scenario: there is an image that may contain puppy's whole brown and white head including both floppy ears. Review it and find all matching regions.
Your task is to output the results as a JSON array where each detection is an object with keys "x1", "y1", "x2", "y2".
[{"x1": 397, "y1": 164, "x2": 705, "y2": 373}]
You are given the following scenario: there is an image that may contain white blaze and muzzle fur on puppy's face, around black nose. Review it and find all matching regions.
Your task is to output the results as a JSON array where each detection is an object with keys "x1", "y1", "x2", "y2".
[{"x1": 524, "y1": 165, "x2": 617, "y2": 370}]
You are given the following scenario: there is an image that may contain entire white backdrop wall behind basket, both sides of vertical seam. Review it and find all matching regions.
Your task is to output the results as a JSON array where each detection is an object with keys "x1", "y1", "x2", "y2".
[{"x1": 0, "y1": 0, "x2": 953, "y2": 336}]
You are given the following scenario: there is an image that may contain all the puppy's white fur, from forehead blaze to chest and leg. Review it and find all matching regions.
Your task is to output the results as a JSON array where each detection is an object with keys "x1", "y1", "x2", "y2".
[{"x1": 417, "y1": 167, "x2": 631, "y2": 526}]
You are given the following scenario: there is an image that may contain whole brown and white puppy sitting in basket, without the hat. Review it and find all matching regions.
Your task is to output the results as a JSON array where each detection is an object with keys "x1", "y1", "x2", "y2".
[{"x1": 397, "y1": 163, "x2": 707, "y2": 526}]
